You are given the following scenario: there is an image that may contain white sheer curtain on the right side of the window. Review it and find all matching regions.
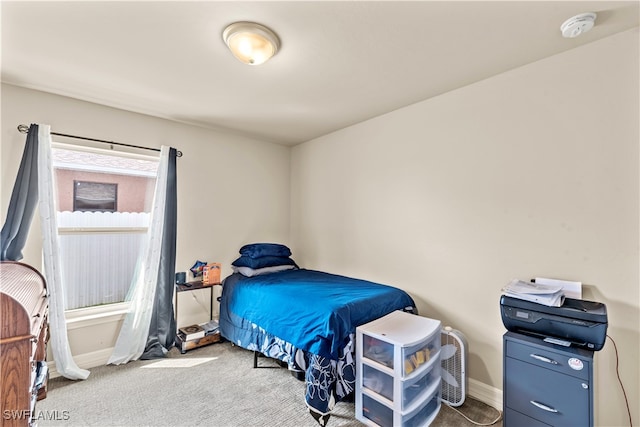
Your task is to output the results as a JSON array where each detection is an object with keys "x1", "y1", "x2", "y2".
[{"x1": 108, "y1": 146, "x2": 170, "y2": 365}]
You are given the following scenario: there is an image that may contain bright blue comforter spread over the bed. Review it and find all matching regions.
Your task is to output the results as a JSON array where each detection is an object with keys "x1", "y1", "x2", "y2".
[{"x1": 221, "y1": 269, "x2": 415, "y2": 359}]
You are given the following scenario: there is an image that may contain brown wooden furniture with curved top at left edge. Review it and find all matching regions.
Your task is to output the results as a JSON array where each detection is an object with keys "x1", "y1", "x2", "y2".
[{"x1": 0, "y1": 261, "x2": 49, "y2": 427}]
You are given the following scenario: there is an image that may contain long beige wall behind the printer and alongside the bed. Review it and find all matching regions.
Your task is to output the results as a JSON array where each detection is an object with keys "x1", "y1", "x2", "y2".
[{"x1": 291, "y1": 28, "x2": 640, "y2": 426}]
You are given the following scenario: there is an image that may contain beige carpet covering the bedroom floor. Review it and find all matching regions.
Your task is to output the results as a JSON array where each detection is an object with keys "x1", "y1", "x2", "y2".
[{"x1": 36, "y1": 342, "x2": 502, "y2": 427}]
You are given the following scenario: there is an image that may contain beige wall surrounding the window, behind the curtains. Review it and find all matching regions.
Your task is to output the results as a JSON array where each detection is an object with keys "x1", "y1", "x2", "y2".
[{"x1": 0, "y1": 85, "x2": 290, "y2": 346}]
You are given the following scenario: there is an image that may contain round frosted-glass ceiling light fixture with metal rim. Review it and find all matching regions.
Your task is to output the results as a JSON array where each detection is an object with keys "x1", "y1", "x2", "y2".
[{"x1": 222, "y1": 22, "x2": 280, "y2": 65}]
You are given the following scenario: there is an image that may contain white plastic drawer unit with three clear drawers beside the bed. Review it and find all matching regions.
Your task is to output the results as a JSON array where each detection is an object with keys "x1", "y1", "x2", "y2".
[{"x1": 356, "y1": 311, "x2": 441, "y2": 427}]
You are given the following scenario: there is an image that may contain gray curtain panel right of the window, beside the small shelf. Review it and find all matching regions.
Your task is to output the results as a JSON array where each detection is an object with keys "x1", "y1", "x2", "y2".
[{"x1": 140, "y1": 148, "x2": 178, "y2": 359}]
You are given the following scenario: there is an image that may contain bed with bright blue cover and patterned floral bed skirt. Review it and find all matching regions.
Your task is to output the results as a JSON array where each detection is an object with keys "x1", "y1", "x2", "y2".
[{"x1": 219, "y1": 247, "x2": 417, "y2": 425}]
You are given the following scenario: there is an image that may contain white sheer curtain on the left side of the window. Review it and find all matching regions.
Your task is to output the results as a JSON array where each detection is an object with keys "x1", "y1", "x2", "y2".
[{"x1": 38, "y1": 125, "x2": 89, "y2": 380}]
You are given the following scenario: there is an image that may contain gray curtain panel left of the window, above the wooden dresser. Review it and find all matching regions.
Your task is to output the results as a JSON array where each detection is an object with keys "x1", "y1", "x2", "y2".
[{"x1": 0, "y1": 124, "x2": 38, "y2": 261}]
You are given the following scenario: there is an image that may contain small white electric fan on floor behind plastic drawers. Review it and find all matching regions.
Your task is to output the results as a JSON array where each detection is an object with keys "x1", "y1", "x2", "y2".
[{"x1": 440, "y1": 326, "x2": 468, "y2": 406}]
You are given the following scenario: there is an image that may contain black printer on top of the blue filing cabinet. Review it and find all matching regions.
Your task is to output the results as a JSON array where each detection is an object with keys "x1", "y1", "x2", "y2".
[{"x1": 500, "y1": 295, "x2": 608, "y2": 350}]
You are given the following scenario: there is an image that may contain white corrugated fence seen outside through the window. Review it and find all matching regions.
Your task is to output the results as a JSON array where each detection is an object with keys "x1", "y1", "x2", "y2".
[{"x1": 58, "y1": 211, "x2": 149, "y2": 310}]
